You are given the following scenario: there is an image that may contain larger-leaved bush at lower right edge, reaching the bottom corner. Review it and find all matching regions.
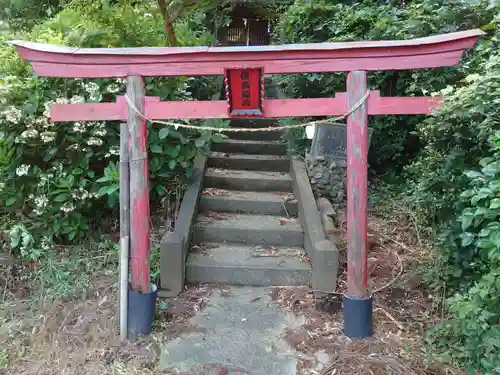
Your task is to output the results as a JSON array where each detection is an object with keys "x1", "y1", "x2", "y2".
[{"x1": 429, "y1": 131, "x2": 500, "y2": 374}]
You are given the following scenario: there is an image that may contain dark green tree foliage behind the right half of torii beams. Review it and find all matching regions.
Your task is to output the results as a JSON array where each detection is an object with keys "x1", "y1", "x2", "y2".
[{"x1": 276, "y1": 0, "x2": 495, "y2": 172}]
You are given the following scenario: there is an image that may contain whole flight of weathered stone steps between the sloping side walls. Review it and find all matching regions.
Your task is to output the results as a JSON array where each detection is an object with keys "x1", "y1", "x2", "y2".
[{"x1": 186, "y1": 120, "x2": 311, "y2": 286}]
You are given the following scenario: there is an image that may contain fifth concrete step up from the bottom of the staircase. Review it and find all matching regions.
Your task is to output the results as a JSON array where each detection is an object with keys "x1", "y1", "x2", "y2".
[{"x1": 208, "y1": 152, "x2": 290, "y2": 172}]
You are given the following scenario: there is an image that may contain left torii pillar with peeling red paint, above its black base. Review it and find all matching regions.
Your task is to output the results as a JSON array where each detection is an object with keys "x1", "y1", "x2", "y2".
[{"x1": 127, "y1": 76, "x2": 151, "y2": 292}]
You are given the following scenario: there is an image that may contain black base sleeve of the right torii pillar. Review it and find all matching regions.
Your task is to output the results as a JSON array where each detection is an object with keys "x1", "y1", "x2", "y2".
[{"x1": 344, "y1": 296, "x2": 373, "y2": 339}]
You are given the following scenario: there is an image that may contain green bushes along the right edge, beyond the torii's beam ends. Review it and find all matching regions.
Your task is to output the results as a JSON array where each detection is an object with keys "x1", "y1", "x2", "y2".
[{"x1": 398, "y1": 14, "x2": 500, "y2": 374}]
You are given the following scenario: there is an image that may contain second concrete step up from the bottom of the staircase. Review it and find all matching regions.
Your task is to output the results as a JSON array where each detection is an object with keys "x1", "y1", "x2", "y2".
[{"x1": 193, "y1": 212, "x2": 304, "y2": 246}]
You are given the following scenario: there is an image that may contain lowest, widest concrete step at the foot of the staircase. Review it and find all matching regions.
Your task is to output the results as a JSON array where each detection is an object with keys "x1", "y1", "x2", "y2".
[{"x1": 186, "y1": 243, "x2": 311, "y2": 286}]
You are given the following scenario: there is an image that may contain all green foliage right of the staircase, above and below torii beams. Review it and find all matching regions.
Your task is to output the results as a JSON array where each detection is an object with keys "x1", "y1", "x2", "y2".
[{"x1": 276, "y1": 0, "x2": 500, "y2": 374}]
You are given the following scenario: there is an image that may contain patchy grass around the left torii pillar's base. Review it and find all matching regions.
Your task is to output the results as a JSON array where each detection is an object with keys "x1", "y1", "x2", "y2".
[{"x1": 0, "y1": 212, "x2": 178, "y2": 375}]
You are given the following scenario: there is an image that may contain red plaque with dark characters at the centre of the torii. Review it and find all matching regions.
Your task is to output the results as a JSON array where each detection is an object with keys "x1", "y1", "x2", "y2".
[{"x1": 225, "y1": 68, "x2": 264, "y2": 117}]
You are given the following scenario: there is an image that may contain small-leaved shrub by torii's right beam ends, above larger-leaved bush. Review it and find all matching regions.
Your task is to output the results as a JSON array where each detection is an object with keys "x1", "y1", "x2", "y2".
[{"x1": 408, "y1": 17, "x2": 500, "y2": 229}]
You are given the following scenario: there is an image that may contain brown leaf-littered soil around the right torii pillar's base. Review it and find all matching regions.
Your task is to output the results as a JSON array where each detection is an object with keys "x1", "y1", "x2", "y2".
[{"x1": 271, "y1": 210, "x2": 465, "y2": 375}]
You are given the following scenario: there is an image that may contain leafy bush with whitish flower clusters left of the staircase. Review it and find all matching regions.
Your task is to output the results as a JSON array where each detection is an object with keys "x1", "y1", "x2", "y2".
[{"x1": 0, "y1": 2, "x2": 220, "y2": 257}]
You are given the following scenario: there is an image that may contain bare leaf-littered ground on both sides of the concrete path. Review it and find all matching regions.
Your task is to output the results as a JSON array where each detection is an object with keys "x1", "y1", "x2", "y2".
[{"x1": 0, "y1": 207, "x2": 461, "y2": 375}]
